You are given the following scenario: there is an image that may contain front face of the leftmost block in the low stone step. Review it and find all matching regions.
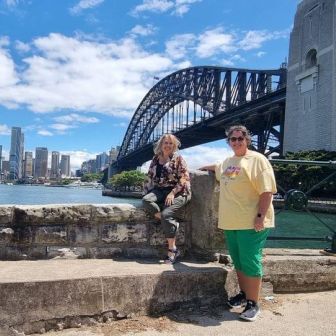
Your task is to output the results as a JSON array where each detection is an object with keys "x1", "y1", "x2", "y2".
[{"x1": 0, "y1": 278, "x2": 102, "y2": 325}]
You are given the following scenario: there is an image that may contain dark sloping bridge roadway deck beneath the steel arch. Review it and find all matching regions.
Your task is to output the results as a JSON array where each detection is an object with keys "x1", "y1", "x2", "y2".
[{"x1": 112, "y1": 87, "x2": 286, "y2": 172}]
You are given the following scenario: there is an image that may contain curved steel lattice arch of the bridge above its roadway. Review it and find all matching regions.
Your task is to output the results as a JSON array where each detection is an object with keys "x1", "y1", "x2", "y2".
[{"x1": 117, "y1": 66, "x2": 286, "y2": 172}]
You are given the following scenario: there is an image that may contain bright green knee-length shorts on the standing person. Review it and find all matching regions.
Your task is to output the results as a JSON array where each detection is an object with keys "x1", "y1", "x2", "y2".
[{"x1": 224, "y1": 229, "x2": 270, "y2": 277}]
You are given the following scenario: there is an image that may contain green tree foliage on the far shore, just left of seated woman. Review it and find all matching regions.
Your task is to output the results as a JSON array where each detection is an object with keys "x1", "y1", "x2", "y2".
[{"x1": 108, "y1": 170, "x2": 146, "y2": 190}]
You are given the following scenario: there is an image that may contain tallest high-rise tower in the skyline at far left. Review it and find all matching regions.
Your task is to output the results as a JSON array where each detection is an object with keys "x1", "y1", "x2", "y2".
[{"x1": 9, "y1": 127, "x2": 24, "y2": 180}]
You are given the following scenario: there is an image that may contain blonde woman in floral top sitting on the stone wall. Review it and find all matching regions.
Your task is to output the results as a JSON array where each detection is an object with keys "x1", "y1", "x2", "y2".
[{"x1": 142, "y1": 134, "x2": 191, "y2": 264}]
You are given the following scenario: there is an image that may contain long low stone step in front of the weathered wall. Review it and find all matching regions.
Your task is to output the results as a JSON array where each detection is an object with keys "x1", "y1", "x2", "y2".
[{"x1": 0, "y1": 259, "x2": 234, "y2": 334}]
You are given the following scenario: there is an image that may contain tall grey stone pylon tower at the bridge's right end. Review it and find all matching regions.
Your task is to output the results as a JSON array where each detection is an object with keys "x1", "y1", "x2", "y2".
[{"x1": 284, "y1": 0, "x2": 336, "y2": 152}]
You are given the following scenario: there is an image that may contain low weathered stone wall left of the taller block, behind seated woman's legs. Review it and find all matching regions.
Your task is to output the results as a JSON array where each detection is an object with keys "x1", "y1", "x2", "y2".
[{"x1": 0, "y1": 204, "x2": 188, "y2": 260}]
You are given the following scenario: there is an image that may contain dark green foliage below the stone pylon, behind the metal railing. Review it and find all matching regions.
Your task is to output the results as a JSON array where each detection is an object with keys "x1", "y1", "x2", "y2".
[{"x1": 273, "y1": 150, "x2": 336, "y2": 197}]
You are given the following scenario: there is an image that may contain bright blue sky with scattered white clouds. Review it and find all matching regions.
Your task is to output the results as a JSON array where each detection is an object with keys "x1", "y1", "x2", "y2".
[{"x1": 0, "y1": 0, "x2": 299, "y2": 170}]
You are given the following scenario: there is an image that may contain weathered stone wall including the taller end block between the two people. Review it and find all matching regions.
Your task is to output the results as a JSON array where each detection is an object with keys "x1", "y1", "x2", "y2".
[{"x1": 0, "y1": 172, "x2": 223, "y2": 260}]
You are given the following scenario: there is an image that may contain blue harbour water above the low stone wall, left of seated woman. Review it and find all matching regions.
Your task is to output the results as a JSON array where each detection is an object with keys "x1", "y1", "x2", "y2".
[{"x1": 0, "y1": 184, "x2": 141, "y2": 206}]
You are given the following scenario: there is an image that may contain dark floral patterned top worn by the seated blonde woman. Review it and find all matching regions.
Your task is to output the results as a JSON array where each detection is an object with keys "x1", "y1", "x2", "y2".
[{"x1": 144, "y1": 153, "x2": 191, "y2": 196}]
